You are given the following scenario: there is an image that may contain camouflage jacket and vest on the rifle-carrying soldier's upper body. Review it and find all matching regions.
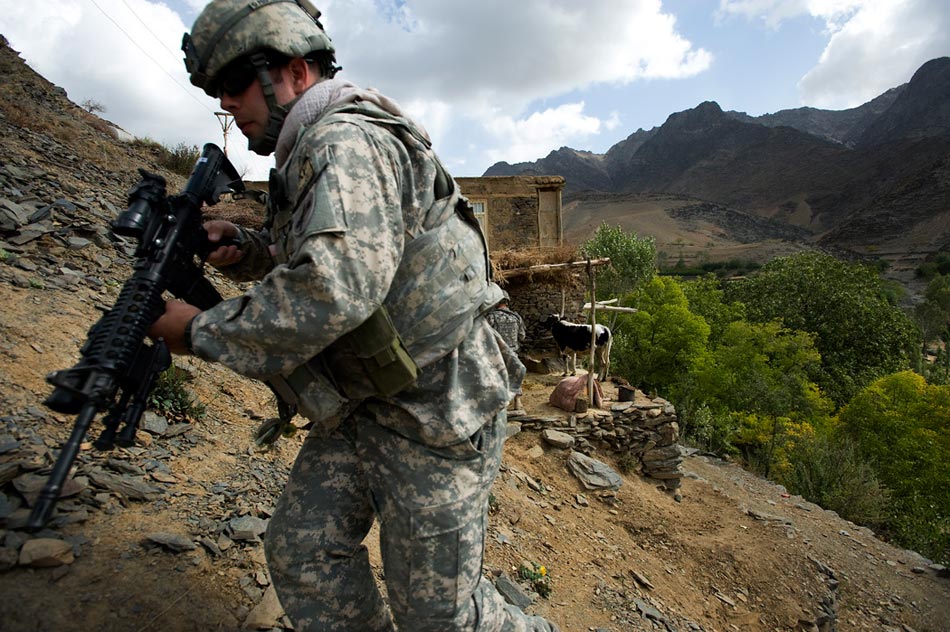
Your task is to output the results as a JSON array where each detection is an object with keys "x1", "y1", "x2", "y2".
[{"x1": 192, "y1": 84, "x2": 524, "y2": 445}]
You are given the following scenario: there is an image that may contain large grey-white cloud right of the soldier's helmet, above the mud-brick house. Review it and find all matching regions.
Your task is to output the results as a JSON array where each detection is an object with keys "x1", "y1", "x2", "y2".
[{"x1": 324, "y1": 0, "x2": 712, "y2": 170}]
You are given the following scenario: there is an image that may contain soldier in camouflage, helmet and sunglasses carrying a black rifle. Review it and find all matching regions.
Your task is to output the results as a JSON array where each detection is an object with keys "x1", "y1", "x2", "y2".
[{"x1": 150, "y1": 0, "x2": 557, "y2": 632}]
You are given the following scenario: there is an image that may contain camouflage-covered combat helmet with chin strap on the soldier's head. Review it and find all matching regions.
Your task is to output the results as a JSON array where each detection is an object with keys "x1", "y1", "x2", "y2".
[{"x1": 181, "y1": 0, "x2": 338, "y2": 155}]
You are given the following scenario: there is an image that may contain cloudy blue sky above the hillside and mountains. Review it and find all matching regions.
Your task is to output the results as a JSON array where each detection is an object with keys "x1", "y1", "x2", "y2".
[{"x1": 0, "y1": 0, "x2": 950, "y2": 180}]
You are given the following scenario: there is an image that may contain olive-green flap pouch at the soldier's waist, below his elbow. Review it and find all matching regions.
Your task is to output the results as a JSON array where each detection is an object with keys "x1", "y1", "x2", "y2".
[{"x1": 348, "y1": 306, "x2": 419, "y2": 397}]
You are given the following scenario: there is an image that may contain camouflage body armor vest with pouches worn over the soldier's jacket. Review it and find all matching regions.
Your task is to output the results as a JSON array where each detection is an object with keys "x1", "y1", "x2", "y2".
[{"x1": 268, "y1": 103, "x2": 502, "y2": 422}]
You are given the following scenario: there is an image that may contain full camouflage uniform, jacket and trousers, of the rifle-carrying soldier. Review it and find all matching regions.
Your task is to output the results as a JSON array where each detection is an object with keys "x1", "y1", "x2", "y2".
[{"x1": 191, "y1": 80, "x2": 556, "y2": 632}]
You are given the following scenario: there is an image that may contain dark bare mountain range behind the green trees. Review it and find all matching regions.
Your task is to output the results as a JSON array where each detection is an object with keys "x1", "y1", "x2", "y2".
[{"x1": 485, "y1": 57, "x2": 950, "y2": 280}]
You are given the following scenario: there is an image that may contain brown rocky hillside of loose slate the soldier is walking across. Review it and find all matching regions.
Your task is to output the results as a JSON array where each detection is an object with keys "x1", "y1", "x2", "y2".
[{"x1": 0, "y1": 37, "x2": 950, "y2": 632}]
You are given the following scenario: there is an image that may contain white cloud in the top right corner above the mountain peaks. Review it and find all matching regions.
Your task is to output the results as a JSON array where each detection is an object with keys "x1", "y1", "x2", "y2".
[{"x1": 719, "y1": 0, "x2": 950, "y2": 109}]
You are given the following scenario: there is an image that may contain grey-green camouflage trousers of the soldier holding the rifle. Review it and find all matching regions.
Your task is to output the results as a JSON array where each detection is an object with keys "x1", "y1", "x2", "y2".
[{"x1": 265, "y1": 408, "x2": 557, "y2": 632}]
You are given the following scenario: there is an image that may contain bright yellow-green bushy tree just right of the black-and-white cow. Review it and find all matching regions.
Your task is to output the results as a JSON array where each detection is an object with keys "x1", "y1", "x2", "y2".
[{"x1": 612, "y1": 277, "x2": 709, "y2": 391}]
